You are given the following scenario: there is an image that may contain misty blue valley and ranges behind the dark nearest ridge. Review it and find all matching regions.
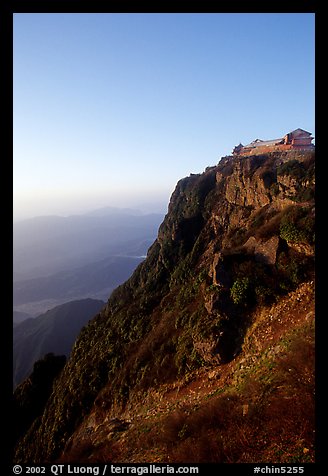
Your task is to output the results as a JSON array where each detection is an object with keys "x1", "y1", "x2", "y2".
[{"x1": 13, "y1": 207, "x2": 163, "y2": 321}]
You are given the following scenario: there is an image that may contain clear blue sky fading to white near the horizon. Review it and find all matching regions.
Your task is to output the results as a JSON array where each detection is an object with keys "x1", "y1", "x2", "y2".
[{"x1": 14, "y1": 13, "x2": 315, "y2": 218}]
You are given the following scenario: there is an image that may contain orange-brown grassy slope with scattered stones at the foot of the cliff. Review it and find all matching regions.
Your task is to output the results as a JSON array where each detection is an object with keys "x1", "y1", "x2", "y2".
[{"x1": 61, "y1": 282, "x2": 314, "y2": 463}]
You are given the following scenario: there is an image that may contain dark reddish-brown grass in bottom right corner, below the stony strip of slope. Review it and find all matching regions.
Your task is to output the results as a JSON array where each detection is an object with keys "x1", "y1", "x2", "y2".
[{"x1": 140, "y1": 328, "x2": 315, "y2": 463}]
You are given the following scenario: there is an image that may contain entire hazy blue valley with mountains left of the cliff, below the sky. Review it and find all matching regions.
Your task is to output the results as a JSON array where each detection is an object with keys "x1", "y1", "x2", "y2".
[{"x1": 13, "y1": 208, "x2": 163, "y2": 386}]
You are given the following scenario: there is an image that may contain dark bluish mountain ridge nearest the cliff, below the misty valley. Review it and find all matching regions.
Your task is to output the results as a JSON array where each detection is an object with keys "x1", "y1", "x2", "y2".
[{"x1": 13, "y1": 299, "x2": 105, "y2": 386}]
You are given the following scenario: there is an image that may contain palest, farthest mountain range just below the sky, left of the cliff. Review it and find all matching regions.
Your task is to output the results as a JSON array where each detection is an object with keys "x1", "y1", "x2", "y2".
[{"x1": 13, "y1": 210, "x2": 163, "y2": 281}]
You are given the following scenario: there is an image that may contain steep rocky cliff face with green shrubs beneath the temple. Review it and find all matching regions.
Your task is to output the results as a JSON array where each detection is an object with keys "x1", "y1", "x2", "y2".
[{"x1": 15, "y1": 151, "x2": 314, "y2": 463}]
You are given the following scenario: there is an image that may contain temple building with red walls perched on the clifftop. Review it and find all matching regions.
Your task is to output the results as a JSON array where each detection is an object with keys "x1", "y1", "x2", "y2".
[{"x1": 232, "y1": 129, "x2": 314, "y2": 155}]
